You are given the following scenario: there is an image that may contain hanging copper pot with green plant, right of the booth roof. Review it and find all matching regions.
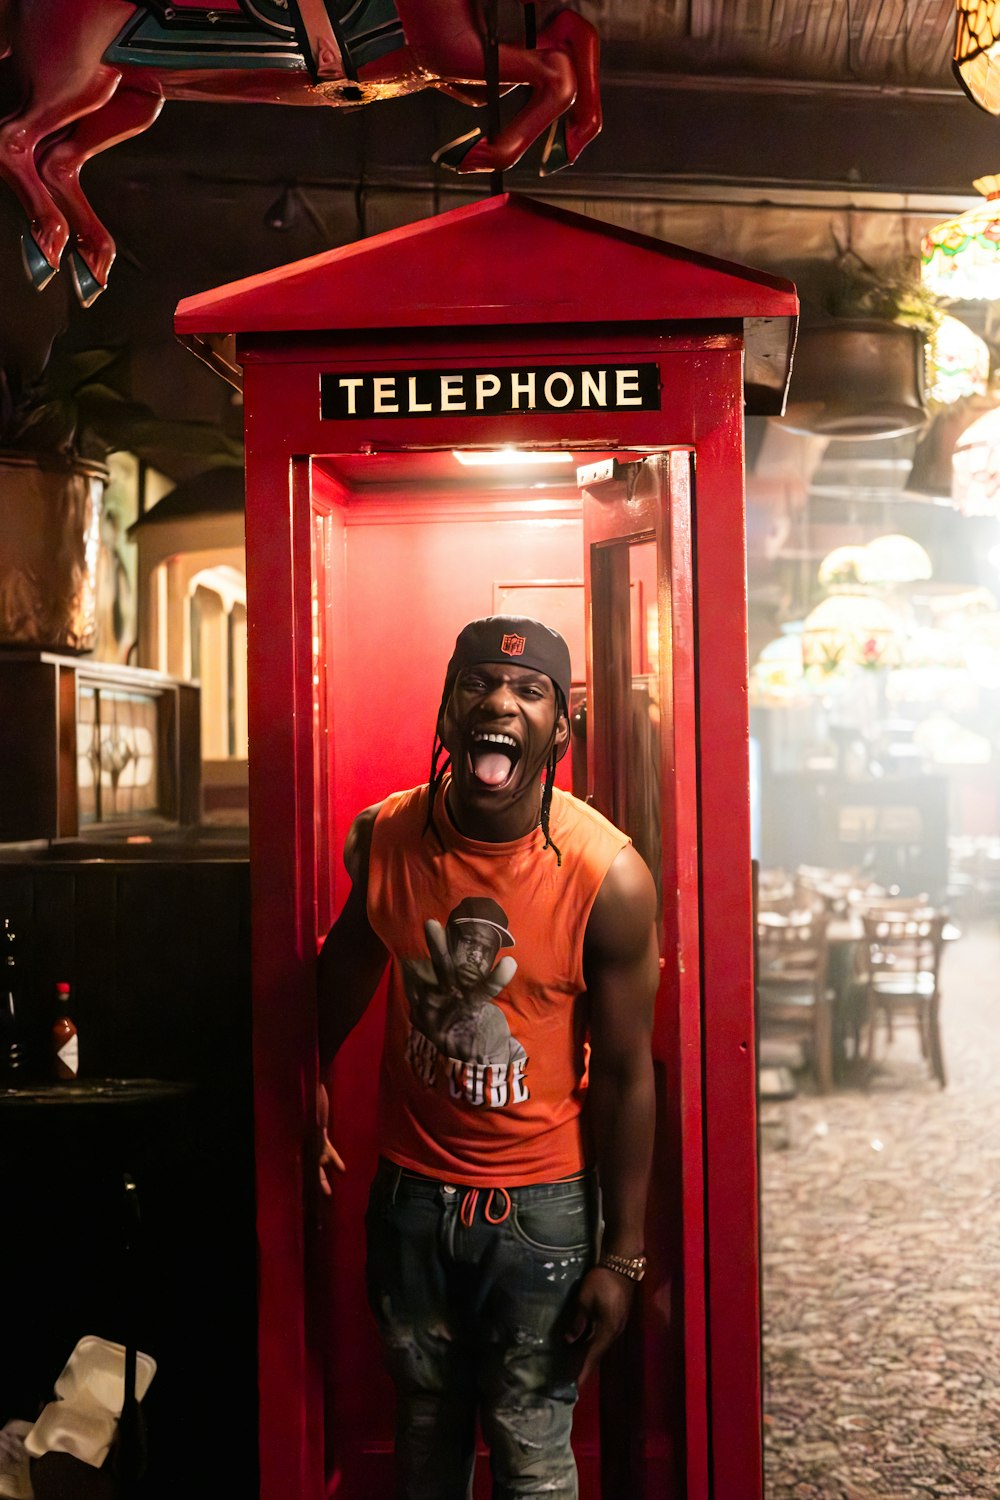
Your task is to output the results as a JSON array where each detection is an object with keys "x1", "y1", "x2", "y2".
[{"x1": 783, "y1": 251, "x2": 943, "y2": 440}]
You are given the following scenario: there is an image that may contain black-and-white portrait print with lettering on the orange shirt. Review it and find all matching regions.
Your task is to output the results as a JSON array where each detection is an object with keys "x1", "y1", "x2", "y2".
[{"x1": 402, "y1": 896, "x2": 528, "y2": 1109}]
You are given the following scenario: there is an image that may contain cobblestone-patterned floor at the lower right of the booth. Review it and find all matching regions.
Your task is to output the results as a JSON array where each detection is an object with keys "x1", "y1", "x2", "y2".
[{"x1": 763, "y1": 926, "x2": 1000, "y2": 1500}]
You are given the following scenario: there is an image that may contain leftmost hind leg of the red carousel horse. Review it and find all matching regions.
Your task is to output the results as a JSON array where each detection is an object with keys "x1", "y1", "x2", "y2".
[{"x1": 0, "y1": 0, "x2": 135, "y2": 288}]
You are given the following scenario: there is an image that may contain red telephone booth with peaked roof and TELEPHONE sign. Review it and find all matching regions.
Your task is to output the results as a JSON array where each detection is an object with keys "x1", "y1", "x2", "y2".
[{"x1": 177, "y1": 195, "x2": 798, "y2": 1500}]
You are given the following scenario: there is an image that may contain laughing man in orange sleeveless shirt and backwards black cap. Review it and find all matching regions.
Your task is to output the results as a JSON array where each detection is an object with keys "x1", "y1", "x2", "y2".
[{"x1": 319, "y1": 617, "x2": 658, "y2": 1500}]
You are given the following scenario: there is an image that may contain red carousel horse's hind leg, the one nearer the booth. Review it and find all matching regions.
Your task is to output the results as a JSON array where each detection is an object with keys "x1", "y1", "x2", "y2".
[{"x1": 37, "y1": 84, "x2": 163, "y2": 308}]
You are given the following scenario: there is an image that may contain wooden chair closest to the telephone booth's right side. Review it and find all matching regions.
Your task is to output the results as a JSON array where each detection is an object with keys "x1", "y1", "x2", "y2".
[{"x1": 757, "y1": 909, "x2": 834, "y2": 1094}]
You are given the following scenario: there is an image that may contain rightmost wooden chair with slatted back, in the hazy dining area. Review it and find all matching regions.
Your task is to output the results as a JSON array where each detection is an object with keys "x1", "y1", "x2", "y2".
[{"x1": 864, "y1": 908, "x2": 948, "y2": 1088}]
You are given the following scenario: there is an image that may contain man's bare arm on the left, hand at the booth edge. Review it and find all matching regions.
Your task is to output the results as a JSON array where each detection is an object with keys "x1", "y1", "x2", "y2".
[{"x1": 316, "y1": 807, "x2": 388, "y2": 1193}]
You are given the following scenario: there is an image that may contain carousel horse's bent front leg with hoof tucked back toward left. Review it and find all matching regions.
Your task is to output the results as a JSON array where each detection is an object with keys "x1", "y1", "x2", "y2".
[{"x1": 396, "y1": 0, "x2": 576, "y2": 173}]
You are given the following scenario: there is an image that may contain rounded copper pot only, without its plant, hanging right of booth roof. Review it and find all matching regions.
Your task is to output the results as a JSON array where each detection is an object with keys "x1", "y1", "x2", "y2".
[{"x1": 781, "y1": 318, "x2": 927, "y2": 440}]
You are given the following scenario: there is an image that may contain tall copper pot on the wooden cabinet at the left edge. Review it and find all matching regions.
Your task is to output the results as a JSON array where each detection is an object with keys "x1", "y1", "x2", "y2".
[{"x1": 0, "y1": 452, "x2": 109, "y2": 651}]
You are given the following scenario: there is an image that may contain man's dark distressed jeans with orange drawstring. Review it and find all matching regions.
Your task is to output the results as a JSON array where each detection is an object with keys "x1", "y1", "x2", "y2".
[{"x1": 366, "y1": 1161, "x2": 598, "y2": 1500}]
